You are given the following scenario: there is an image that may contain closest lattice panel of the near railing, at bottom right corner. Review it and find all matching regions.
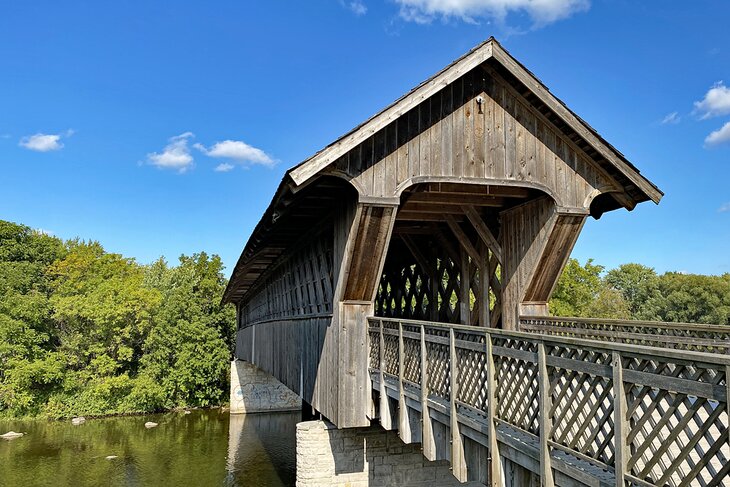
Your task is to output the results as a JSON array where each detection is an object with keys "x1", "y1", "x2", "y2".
[{"x1": 624, "y1": 357, "x2": 730, "y2": 487}]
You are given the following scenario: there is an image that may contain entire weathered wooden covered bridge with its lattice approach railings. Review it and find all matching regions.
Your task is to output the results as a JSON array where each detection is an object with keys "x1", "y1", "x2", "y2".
[{"x1": 224, "y1": 39, "x2": 730, "y2": 486}]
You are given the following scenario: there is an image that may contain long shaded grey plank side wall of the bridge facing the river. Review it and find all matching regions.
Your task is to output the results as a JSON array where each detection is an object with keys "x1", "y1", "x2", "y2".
[{"x1": 236, "y1": 226, "x2": 341, "y2": 420}]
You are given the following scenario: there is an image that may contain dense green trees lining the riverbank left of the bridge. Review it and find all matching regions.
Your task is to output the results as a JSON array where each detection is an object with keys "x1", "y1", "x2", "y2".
[{"x1": 0, "y1": 221, "x2": 235, "y2": 418}]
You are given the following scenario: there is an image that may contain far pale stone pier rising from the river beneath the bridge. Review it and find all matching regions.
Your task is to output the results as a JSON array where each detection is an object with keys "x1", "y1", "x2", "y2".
[{"x1": 231, "y1": 360, "x2": 302, "y2": 414}]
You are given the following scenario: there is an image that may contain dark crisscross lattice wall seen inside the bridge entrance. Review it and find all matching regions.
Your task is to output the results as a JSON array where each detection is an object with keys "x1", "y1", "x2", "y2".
[{"x1": 375, "y1": 230, "x2": 501, "y2": 325}]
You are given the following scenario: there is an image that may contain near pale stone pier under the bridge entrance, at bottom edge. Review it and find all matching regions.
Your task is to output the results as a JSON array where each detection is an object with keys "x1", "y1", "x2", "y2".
[{"x1": 297, "y1": 421, "x2": 483, "y2": 487}]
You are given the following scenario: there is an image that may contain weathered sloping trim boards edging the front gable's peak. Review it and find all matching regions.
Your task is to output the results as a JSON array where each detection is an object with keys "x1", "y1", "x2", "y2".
[{"x1": 287, "y1": 37, "x2": 664, "y2": 203}]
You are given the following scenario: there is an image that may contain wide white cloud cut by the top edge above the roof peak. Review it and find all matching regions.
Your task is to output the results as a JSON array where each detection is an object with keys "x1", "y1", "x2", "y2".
[{"x1": 395, "y1": 0, "x2": 590, "y2": 26}]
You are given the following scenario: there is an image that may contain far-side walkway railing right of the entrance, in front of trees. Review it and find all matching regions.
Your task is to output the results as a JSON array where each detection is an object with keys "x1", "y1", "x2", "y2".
[{"x1": 520, "y1": 316, "x2": 730, "y2": 354}]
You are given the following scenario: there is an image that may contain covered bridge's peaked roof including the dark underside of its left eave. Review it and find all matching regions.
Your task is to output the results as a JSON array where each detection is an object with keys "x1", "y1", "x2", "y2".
[{"x1": 223, "y1": 38, "x2": 663, "y2": 302}]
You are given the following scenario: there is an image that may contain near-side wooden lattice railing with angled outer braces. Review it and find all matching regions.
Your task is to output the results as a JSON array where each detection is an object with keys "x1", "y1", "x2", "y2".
[{"x1": 369, "y1": 318, "x2": 730, "y2": 486}]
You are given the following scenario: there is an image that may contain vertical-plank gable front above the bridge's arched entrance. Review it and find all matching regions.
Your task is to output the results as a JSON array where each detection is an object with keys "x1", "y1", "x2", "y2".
[{"x1": 331, "y1": 67, "x2": 619, "y2": 208}]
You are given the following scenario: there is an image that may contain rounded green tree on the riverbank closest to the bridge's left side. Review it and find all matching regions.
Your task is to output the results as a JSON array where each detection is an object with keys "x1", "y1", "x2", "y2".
[{"x1": 142, "y1": 253, "x2": 235, "y2": 407}]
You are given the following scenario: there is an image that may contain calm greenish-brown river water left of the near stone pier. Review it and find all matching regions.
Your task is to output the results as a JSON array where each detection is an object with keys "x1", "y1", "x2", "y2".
[{"x1": 0, "y1": 410, "x2": 301, "y2": 487}]
